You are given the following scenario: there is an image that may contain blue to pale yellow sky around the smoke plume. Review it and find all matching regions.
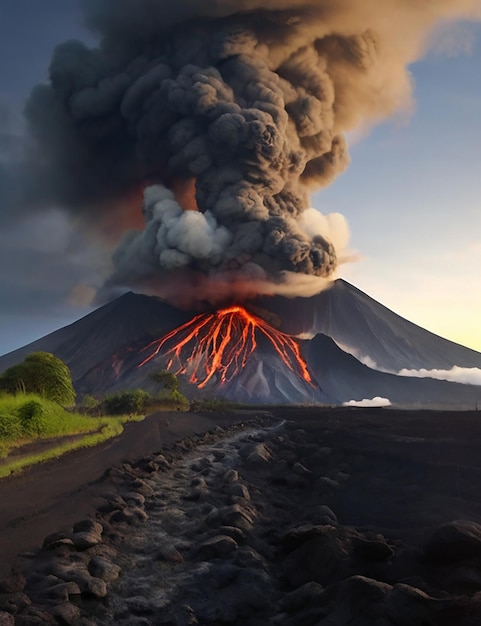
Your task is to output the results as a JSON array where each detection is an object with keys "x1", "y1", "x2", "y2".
[{"x1": 0, "y1": 0, "x2": 481, "y2": 354}]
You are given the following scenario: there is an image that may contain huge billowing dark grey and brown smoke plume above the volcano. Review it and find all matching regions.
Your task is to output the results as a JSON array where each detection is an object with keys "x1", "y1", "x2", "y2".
[{"x1": 20, "y1": 0, "x2": 479, "y2": 297}]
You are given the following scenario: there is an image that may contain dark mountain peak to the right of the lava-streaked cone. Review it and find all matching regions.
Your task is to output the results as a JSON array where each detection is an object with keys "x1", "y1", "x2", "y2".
[{"x1": 265, "y1": 279, "x2": 481, "y2": 372}]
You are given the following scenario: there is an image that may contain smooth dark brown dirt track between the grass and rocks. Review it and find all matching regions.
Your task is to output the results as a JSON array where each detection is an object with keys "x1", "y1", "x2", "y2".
[{"x1": 0, "y1": 412, "x2": 255, "y2": 577}]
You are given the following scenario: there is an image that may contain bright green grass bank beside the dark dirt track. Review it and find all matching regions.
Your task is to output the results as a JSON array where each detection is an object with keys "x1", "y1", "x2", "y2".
[{"x1": 0, "y1": 394, "x2": 143, "y2": 477}]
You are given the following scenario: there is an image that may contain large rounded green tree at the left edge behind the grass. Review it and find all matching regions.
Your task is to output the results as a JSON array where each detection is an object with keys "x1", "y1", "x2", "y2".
[{"x1": 0, "y1": 352, "x2": 75, "y2": 406}]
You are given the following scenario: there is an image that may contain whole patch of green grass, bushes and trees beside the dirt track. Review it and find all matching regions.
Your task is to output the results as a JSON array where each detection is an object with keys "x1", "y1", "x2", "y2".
[{"x1": 0, "y1": 366, "x2": 189, "y2": 477}]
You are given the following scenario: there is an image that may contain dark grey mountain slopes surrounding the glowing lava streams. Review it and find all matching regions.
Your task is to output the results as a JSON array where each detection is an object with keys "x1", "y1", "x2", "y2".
[{"x1": 0, "y1": 280, "x2": 481, "y2": 409}]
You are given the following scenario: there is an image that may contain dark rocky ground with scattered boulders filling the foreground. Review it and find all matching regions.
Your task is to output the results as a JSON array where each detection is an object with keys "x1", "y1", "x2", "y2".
[{"x1": 0, "y1": 408, "x2": 481, "y2": 626}]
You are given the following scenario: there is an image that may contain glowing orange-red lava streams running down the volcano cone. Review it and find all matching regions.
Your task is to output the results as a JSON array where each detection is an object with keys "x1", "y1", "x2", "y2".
[{"x1": 139, "y1": 306, "x2": 312, "y2": 388}]
